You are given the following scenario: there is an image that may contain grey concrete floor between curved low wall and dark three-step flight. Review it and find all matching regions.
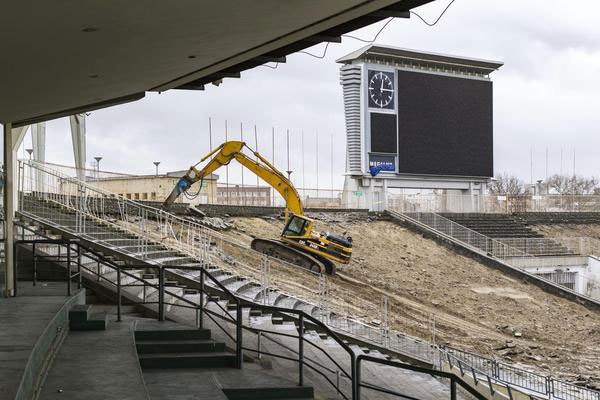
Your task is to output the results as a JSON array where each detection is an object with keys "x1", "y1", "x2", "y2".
[{"x1": 40, "y1": 308, "x2": 149, "y2": 400}]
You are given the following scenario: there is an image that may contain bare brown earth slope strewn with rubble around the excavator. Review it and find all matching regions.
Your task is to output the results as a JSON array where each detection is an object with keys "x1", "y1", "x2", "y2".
[{"x1": 217, "y1": 213, "x2": 600, "y2": 387}]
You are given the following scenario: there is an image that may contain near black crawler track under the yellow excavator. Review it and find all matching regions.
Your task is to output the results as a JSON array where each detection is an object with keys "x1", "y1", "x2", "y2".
[{"x1": 250, "y1": 239, "x2": 335, "y2": 275}]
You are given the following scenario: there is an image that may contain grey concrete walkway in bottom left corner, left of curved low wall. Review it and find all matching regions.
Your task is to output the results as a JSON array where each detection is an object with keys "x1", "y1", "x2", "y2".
[{"x1": 0, "y1": 282, "x2": 77, "y2": 399}]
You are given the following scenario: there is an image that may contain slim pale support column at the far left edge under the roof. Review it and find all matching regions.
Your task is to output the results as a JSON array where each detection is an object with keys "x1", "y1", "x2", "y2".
[{"x1": 4, "y1": 123, "x2": 15, "y2": 297}]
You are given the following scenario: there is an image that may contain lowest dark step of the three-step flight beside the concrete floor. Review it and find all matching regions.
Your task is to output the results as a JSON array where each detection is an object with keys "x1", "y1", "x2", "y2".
[{"x1": 138, "y1": 352, "x2": 236, "y2": 368}]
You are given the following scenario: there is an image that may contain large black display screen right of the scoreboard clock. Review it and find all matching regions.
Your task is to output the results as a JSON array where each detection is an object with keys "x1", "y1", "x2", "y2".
[{"x1": 396, "y1": 71, "x2": 494, "y2": 177}]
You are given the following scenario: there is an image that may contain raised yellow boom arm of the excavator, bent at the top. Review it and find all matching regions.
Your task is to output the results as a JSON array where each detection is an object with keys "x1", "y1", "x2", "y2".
[{"x1": 163, "y1": 141, "x2": 304, "y2": 215}]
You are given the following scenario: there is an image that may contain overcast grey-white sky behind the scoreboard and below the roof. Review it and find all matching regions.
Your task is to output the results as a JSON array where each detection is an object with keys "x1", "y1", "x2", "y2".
[{"x1": 24, "y1": 0, "x2": 600, "y2": 188}]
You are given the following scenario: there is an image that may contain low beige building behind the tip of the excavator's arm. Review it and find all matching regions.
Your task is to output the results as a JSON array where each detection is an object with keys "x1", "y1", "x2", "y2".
[{"x1": 87, "y1": 170, "x2": 219, "y2": 204}]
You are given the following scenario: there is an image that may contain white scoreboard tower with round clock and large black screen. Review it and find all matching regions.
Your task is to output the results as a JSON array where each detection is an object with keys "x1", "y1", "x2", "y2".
[{"x1": 337, "y1": 44, "x2": 503, "y2": 210}]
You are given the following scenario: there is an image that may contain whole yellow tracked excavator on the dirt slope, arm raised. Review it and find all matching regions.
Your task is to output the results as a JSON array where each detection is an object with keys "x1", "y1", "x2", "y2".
[{"x1": 163, "y1": 141, "x2": 352, "y2": 275}]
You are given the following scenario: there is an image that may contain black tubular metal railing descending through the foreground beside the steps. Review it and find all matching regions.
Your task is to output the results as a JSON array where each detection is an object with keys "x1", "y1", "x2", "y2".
[{"x1": 15, "y1": 239, "x2": 485, "y2": 400}]
